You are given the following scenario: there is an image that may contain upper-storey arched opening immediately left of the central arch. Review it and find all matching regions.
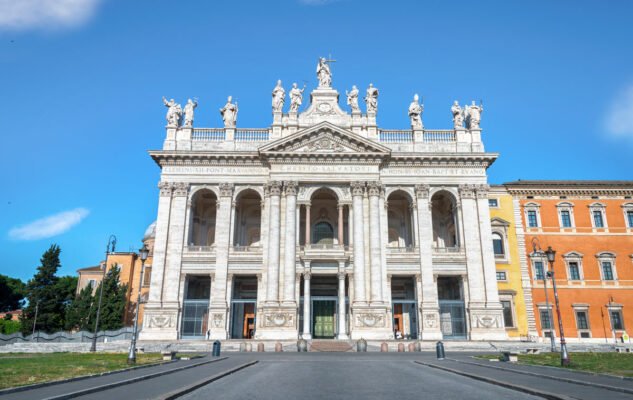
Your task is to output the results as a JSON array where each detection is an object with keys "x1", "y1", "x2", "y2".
[{"x1": 233, "y1": 189, "x2": 262, "y2": 247}]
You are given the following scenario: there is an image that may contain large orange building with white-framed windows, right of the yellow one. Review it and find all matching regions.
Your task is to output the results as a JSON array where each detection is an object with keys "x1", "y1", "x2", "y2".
[{"x1": 504, "y1": 181, "x2": 633, "y2": 341}]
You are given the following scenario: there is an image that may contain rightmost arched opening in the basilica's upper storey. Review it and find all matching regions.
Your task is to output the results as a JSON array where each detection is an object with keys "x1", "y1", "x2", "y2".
[{"x1": 431, "y1": 191, "x2": 459, "y2": 248}]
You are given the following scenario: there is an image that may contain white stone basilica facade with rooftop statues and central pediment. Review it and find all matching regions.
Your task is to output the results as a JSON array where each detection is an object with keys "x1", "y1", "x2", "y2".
[{"x1": 140, "y1": 60, "x2": 507, "y2": 340}]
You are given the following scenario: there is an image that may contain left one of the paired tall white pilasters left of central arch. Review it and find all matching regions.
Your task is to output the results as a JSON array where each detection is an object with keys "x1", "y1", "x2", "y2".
[{"x1": 266, "y1": 181, "x2": 281, "y2": 305}]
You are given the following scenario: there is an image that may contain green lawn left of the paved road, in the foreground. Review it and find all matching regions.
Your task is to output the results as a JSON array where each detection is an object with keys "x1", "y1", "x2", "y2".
[{"x1": 0, "y1": 353, "x2": 169, "y2": 389}]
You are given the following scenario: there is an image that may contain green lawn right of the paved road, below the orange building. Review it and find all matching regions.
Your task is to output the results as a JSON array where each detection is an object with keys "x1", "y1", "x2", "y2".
[{"x1": 478, "y1": 353, "x2": 633, "y2": 378}]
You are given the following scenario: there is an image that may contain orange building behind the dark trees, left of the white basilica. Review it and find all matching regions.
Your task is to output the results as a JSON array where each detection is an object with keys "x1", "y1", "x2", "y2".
[{"x1": 77, "y1": 223, "x2": 156, "y2": 326}]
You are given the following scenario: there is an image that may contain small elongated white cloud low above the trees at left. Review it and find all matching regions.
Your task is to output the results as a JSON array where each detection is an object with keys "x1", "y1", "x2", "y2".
[{"x1": 9, "y1": 208, "x2": 90, "y2": 240}]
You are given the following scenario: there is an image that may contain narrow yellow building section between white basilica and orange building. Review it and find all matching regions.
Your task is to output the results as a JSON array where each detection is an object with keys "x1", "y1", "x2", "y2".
[{"x1": 488, "y1": 186, "x2": 538, "y2": 340}]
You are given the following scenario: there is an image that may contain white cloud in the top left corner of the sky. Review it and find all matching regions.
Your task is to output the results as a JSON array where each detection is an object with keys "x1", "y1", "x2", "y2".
[{"x1": 0, "y1": 0, "x2": 102, "y2": 31}]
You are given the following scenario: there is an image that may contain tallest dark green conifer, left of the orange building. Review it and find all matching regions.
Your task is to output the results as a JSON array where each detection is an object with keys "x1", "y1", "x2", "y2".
[{"x1": 21, "y1": 244, "x2": 64, "y2": 335}]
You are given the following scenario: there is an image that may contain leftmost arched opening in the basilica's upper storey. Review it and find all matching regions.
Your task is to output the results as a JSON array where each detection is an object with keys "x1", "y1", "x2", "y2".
[{"x1": 189, "y1": 189, "x2": 217, "y2": 246}]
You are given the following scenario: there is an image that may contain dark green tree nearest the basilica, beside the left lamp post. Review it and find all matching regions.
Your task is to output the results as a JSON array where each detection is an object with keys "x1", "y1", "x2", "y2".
[{"x1": 89, "y1": 264, "x2": 127, "y2": 332}]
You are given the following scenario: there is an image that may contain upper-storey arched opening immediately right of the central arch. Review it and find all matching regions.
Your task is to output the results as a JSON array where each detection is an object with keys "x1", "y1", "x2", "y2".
[{"x1": 387, "y1": 190, "x2": 415, "y2": 247}]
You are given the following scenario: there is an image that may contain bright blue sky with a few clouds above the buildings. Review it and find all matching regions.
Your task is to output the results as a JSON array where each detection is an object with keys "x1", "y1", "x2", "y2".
[{"x1": 0, "y1": 0, "x2": 633, "y2": 279}]
